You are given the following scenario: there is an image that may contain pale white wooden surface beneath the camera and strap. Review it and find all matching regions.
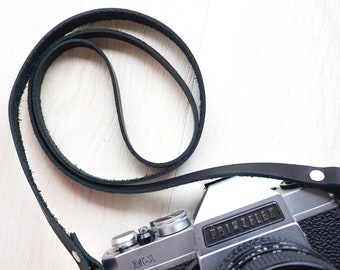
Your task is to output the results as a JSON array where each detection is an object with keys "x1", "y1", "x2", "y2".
[{"x1": 0, "y1": 0, "x2": 340, "y2": 270}]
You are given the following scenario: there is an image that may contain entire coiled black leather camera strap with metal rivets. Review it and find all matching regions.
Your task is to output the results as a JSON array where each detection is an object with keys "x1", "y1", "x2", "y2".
[{"x1": 9, "y1": 9, "x2": 340, "y2": 270}]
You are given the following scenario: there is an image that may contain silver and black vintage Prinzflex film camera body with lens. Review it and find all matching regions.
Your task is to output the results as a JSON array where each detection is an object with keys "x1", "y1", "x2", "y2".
[{"x1": 102, "y1": 177, "x2": 340, "y2": 270}]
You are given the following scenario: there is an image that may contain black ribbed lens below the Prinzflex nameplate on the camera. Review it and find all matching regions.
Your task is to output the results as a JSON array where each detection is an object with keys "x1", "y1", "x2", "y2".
[{"x1": 218, "y1": 238, "x2": 336, "y2": 270}]
